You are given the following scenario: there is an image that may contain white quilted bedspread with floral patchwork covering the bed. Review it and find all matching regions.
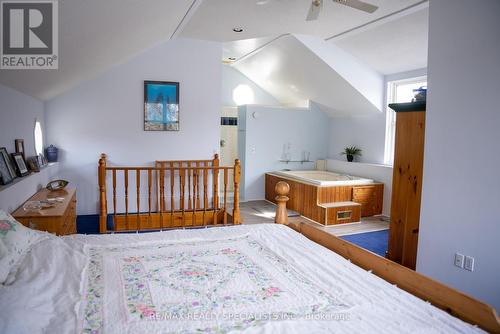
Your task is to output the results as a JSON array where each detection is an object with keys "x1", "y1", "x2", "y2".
[{"x1": 0, "y1": 224, "x2": 482, "y2": 334}]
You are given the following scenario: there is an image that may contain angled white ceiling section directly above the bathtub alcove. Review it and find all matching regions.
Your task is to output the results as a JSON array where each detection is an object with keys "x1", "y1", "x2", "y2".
[{"x1": 233, "y1": 35, "x2": 383, "y2": 115}]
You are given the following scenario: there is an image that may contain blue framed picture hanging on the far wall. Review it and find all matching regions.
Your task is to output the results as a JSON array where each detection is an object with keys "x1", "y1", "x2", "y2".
[{"x1": 144, "y1": 81, "x2": 179, "y2": 131}]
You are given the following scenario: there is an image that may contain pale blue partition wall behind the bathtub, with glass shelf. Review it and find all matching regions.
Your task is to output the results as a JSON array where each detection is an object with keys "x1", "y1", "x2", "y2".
[{"x1": 238, "y1": 106, "x2": 328, "y2": 201}]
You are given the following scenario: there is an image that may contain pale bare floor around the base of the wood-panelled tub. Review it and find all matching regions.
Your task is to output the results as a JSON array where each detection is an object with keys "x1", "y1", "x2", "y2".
[{"x1": 235, "y1": 201, "x2": 389, "y2": 236}]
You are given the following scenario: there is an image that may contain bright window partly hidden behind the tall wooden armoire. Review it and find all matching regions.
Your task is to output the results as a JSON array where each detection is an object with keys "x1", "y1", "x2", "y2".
[{"x1": 384, "y1": 76, "x2": 427, "y2": 165}]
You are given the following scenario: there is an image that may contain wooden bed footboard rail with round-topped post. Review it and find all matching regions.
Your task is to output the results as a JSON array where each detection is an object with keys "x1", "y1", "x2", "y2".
[{"x1": 275, "y1": 181, "x2": 500, "y2": 333}]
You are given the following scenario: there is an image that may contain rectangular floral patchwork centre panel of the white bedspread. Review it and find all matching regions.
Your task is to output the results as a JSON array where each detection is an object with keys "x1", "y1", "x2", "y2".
[{"x1": 80, "y1": 235, "x2": 350, "y2": 333}]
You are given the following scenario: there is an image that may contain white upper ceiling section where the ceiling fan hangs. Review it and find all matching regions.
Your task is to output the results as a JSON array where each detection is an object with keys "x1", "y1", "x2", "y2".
[{"x1": 182, "y1": 0, "x2": 422, "y2": 42}]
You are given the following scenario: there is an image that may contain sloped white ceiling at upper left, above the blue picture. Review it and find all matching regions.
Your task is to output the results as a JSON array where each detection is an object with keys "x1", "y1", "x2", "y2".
[{"x1": 0, "y1": 0, "x2": 193, "y2": 100}]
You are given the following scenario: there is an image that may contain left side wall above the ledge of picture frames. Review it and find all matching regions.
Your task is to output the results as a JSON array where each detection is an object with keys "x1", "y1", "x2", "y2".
[{"x1": 0, "y1": 85, "x2": 47, "y2": 157}]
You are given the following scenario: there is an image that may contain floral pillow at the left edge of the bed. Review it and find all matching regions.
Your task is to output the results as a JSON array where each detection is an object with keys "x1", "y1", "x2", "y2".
[{"x1": 0, "y1": 210, "x2": 50, "y2": 284}]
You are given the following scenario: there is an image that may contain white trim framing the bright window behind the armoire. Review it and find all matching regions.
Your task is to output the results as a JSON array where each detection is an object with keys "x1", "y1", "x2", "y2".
[{"x1": 384, "y1": 75, "x2": 427, "y2": 166}]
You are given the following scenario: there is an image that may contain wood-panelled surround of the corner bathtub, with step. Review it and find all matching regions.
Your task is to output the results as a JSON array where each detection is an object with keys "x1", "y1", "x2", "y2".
[{"x1": 266, "y1": 173, "x2": 384, "y2": 225}]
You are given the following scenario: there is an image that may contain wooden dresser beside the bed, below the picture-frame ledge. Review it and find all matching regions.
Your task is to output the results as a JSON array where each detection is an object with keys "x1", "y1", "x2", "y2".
[{"x1": 12, "y1": 188, "x2": 76, "y2": 235}]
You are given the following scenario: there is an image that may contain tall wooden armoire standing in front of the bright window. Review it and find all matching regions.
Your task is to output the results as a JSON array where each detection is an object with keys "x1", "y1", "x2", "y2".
[{"x1": 387, "y1": 101, "x2": 425, "y2": 269}]
